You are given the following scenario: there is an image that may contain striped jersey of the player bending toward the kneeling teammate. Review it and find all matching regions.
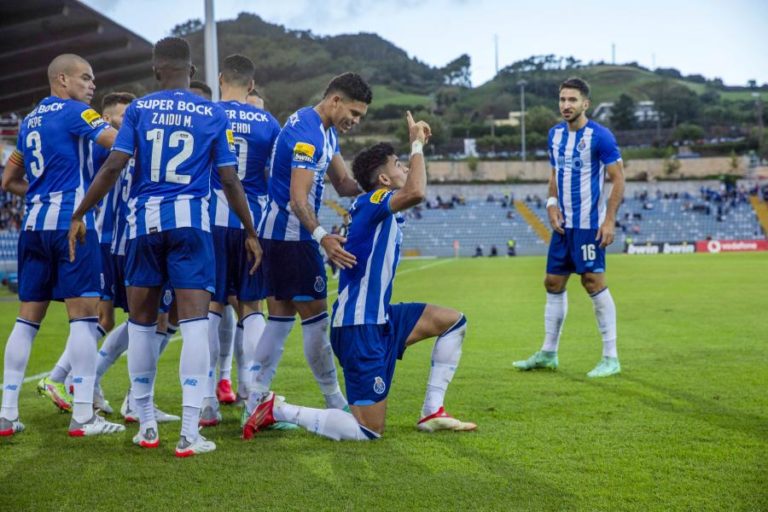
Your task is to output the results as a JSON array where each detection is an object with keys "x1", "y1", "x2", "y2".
[{"x1": 259, "y1": 107, "x2": 339, "y2": 241}]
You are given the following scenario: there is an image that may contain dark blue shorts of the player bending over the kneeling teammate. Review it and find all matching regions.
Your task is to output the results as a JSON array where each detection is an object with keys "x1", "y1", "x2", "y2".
[{"x1": 259, "y1": 239, "x2": 328, "y2": 301}]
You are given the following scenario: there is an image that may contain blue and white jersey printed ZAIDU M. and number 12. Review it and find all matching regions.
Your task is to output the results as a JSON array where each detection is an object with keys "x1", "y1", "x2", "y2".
[{"x1": 112, "y1": 89, "x2": 237, "y2": 239}]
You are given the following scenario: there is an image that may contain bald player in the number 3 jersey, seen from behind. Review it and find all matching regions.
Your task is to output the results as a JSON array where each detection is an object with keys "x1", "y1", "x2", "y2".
[{"x1": 0, "y1": 54, "x2": 125, "y2": 437}]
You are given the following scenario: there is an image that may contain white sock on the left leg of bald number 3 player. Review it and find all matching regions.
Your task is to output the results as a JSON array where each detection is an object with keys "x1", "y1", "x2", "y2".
[{"x1": 0, "y1": 318, "x2": 40, "y2": 420}]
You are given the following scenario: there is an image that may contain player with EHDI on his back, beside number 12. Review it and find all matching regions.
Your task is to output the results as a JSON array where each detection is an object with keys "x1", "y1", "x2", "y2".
[{"x1": 200, "y1": 55, "x2": 280, "y2": 426}]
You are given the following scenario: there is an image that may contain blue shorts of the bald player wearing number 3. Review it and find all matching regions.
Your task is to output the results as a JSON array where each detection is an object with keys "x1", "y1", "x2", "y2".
[{"x1": 18, "y1": 229, "x2": 101, "y2": 302}]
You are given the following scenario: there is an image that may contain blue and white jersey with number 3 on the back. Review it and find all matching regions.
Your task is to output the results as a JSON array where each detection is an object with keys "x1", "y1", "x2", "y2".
[{"x1": 16, "y1": 96, "x2": 109, "y2": 231}]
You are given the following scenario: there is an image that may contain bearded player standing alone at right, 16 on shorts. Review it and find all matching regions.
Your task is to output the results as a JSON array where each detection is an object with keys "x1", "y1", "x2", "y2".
[{"x1": 512, "y1": 78, "x2": 624, "y2": 377}]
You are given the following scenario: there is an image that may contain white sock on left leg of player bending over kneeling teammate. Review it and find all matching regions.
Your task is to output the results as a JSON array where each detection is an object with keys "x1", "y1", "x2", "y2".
[{"x1": 246, "y1": 315, "x2": 294, "y2": 411}]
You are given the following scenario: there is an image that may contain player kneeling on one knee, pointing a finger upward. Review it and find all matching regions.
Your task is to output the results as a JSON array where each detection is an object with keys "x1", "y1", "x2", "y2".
[{"x1": 243, "y1": 112, "x2": 477, "y2": 441}]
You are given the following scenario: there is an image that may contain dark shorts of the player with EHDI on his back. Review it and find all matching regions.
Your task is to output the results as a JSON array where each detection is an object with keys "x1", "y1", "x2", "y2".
[{"x1": 211, "y1": 226, "x2": 267, "y2": 304}]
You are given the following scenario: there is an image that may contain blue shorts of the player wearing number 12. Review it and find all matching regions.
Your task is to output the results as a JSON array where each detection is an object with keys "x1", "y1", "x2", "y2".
[{"x1": 125, "y1": 228, "x2": 215, "y2": 293}]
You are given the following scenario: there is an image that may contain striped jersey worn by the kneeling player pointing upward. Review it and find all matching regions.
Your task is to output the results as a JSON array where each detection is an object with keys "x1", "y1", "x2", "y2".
[{"x1": 331, "y1": 189, "x2": 405, "y2": 327}]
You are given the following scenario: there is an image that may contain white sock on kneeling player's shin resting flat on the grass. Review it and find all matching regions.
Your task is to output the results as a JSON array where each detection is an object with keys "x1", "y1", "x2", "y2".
[{"x1": 273, "y1": 403, "x2": 381, "y2": 441}]
